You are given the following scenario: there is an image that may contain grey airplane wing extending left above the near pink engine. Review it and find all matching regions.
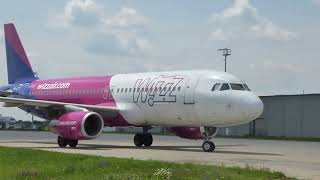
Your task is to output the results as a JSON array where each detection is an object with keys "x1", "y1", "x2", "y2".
[{"x1": 0, "y1": 97, "x2": 119, "y2": 118}]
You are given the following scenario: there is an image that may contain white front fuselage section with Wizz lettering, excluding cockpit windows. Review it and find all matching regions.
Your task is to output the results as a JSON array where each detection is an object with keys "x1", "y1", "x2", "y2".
[{"x1": 110, "y1": 71, "x2": 263, "y2": 127}]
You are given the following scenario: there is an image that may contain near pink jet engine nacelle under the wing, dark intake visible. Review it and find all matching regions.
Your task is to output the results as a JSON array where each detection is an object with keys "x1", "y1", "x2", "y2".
[{"x1": 50, "y1": 111, "x2": 104, "y2": 139}]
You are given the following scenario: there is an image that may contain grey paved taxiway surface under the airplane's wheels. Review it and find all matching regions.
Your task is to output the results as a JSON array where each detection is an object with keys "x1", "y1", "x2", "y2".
[{"x1": 0, "y1": 131, "x2": 320, "y2": 179}]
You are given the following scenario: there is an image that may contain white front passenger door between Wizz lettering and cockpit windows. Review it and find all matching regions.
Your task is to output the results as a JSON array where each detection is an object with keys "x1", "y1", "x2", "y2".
[{"x1": 184, "y1": 76, "x2": 199, "y2": 104}]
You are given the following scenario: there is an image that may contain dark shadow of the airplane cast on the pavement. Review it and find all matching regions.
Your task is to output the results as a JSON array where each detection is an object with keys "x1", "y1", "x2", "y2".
[{"x1": 0, "y1": 141, "x2": 283, "y2": 156}]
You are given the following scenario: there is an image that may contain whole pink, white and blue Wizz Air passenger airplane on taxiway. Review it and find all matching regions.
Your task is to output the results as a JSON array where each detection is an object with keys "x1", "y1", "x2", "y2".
[{"x1": 0, "y1": 23, "x2": 263, "y2": 152}]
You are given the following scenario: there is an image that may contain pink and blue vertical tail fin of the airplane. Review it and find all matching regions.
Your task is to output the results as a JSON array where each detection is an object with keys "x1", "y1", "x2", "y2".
[{"x1": 4, "y1": 23, "x2": 38, "y2": 84}]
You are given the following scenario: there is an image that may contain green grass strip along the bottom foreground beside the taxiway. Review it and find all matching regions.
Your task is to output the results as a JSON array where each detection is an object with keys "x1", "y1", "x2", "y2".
[{"x1": 0, "y1": 147, "x2": 289, "y2": 180}]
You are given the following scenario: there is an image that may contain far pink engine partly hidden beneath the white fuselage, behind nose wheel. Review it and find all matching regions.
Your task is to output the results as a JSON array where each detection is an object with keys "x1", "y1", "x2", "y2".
[{"x1": 169, "y1": 127, "x2": 218, "y2": 139}]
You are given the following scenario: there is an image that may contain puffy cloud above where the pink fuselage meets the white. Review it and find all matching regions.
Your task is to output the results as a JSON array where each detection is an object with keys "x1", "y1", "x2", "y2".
[{"x1": 86, "y1": 7, "x2": 151, "y2": 56}]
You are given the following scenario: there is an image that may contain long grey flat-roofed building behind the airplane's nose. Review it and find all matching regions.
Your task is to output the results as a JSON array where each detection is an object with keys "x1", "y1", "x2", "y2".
[{"x1": 218, "y1": 94, "x2": 320, "y2": 137}]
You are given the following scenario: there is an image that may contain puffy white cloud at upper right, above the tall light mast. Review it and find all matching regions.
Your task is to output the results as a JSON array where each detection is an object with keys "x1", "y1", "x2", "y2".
[{"x1": 210, "y1": 0, "x2": 297, "y2": 41}]
